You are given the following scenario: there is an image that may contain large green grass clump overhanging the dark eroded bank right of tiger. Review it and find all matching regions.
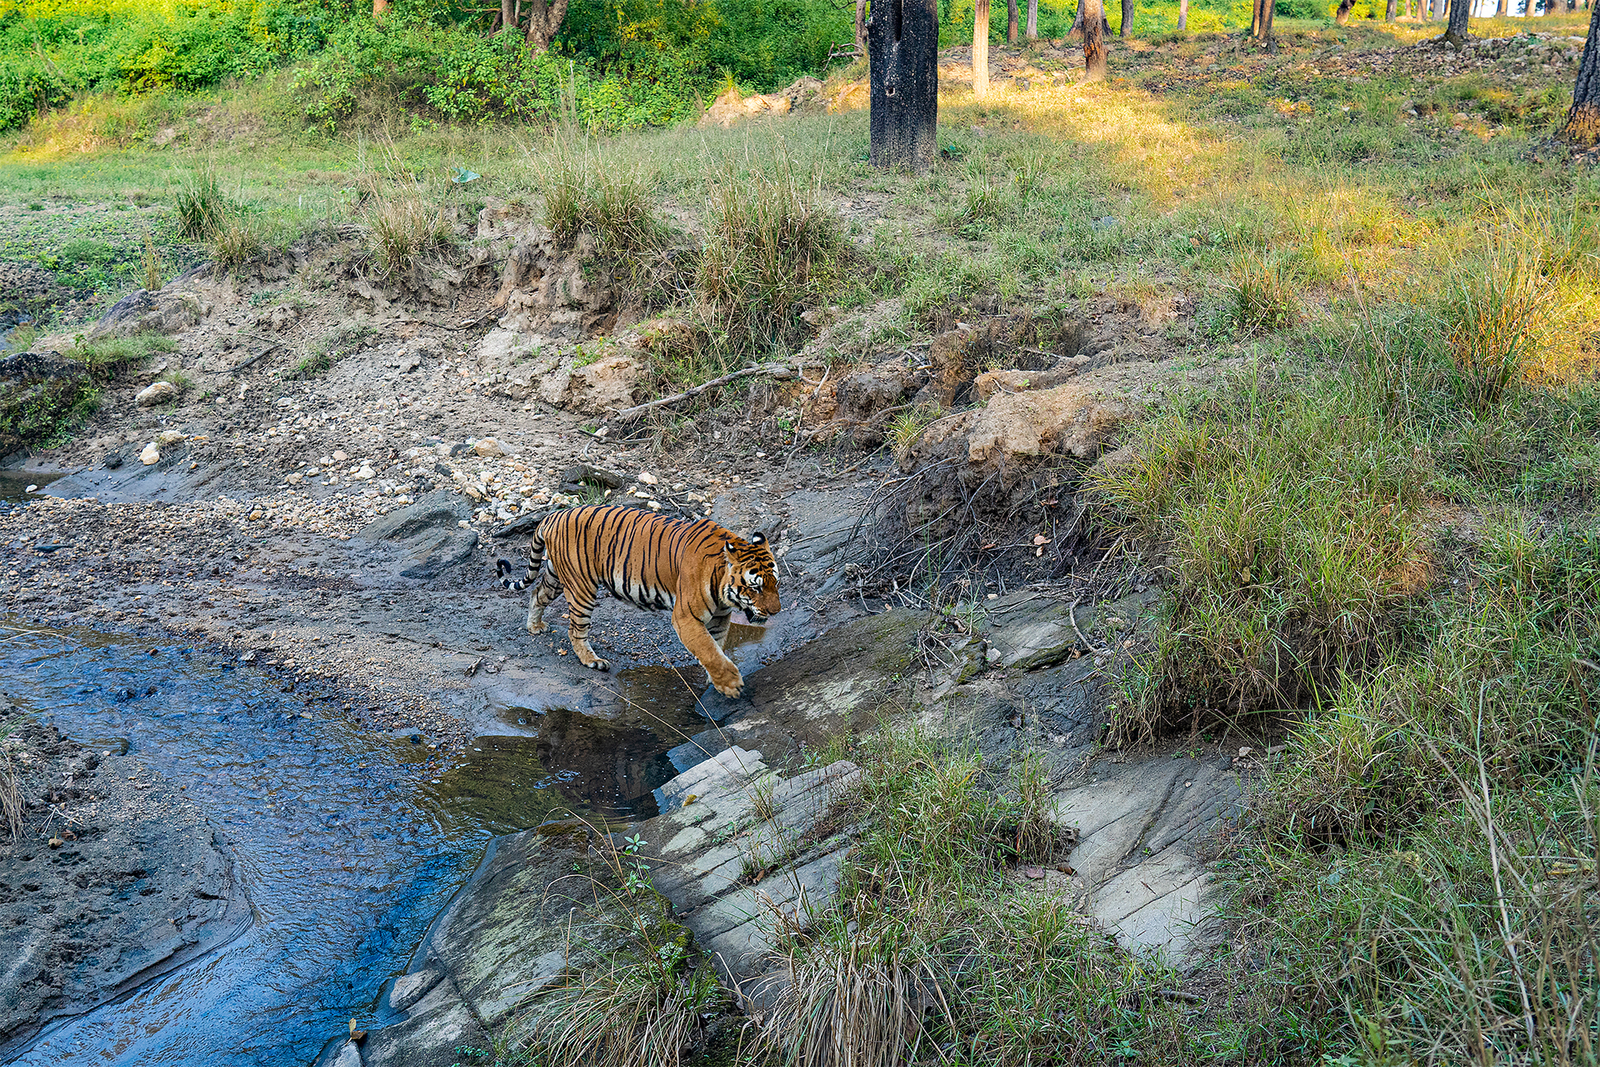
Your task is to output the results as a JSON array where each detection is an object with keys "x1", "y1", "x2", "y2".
[{"x1": 1094, "y1": 373, "x2": 1430, "y2": 739}]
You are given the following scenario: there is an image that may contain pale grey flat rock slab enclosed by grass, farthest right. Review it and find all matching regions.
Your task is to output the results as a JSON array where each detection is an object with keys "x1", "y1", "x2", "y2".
[{"x1": 1056, "y1": 755, "x2": 1240, "y2": 968}]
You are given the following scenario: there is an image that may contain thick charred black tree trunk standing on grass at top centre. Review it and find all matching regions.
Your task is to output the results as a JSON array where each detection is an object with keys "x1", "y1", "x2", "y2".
[{"x1": 867, "y1": 0, "x2": 939, "y2": 174}]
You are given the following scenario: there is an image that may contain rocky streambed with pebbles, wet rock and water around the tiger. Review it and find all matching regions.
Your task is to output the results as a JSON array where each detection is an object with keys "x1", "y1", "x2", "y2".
[{"x1": 0, "y1": 205, "x2": 1253, "y2": 1067}]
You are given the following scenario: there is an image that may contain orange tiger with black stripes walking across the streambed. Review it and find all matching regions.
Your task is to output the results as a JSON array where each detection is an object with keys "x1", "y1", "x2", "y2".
[{"x1": 494, "y1": 504, "x2": 781, "y2": 696}]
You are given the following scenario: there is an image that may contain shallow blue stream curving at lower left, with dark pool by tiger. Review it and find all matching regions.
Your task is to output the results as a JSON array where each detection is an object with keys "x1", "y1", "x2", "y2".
[{"x1": 0, "y1": 621, "x2": 675, "y2": 1067}]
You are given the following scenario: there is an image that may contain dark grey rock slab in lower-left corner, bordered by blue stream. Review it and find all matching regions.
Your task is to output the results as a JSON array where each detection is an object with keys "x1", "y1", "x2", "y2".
[{"x1": 0, "y1": 697, "x2": 251, "y2": 1059}]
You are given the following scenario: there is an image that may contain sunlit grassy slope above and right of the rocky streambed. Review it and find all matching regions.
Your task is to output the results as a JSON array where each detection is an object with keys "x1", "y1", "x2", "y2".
[{"x1": 0, "y1": 6, "x2": 1600, "y2": 1064}]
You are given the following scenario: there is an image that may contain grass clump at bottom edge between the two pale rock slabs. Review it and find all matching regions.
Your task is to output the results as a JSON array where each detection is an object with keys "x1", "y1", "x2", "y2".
[{"x1": 762, "y1": 728, "x2": 1194, "y2": 1067}]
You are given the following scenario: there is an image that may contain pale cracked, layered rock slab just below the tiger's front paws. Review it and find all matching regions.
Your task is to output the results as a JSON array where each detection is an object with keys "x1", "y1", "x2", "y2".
[{"x1": 640, "y1": 747, "x2": 861, "y2": 1003}]
